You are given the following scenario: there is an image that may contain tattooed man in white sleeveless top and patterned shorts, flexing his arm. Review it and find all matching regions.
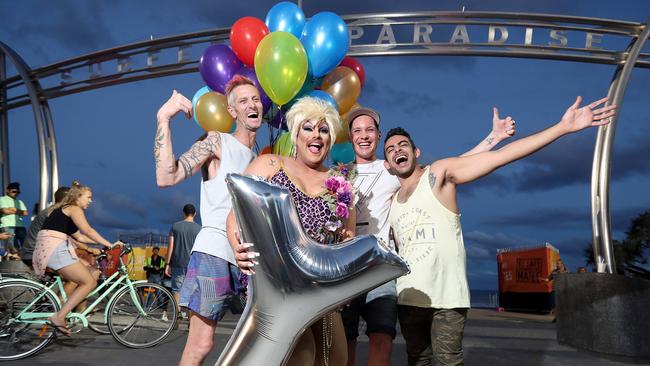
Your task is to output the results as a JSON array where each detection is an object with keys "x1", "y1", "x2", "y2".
[{"x1": 154, "y1": 75, "x2": 263, "y2": 365}]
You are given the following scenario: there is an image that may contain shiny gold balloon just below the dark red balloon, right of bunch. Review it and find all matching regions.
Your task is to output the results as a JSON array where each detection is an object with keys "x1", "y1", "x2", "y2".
[{"x1": 321, "y1": 66, "x2": 361, "y2": 114}]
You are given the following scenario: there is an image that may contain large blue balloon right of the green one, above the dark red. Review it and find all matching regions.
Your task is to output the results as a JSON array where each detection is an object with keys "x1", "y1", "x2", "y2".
[{"x1": 300, "y1": 11, "x2": 350, "y2": 78}]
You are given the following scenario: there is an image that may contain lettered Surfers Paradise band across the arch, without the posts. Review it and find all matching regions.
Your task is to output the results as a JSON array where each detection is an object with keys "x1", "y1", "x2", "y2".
[{"x1": 0, "y1": 12, "x2": 650, "y2": 110}]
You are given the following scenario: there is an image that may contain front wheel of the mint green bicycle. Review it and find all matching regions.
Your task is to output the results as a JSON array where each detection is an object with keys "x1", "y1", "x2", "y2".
[{"x1": 108, "y1": 283, "x2": 178, "y2": 348}]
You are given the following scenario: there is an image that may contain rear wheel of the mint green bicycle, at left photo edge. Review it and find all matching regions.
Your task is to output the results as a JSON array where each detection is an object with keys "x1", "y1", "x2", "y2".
[{"x1": 0, "y1": 281, "x2": 59, "y2": 361}]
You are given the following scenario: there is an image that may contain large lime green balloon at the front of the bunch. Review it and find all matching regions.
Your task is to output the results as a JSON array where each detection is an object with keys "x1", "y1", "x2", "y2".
[{"x1": 255, "y1": 31, "x2": 308, "y2": 105}]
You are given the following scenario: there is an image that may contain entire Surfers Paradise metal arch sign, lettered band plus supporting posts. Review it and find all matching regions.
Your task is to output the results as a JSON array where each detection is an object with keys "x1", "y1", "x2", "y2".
[{"x1": 0, "y1": 12, "x2": 650, "y2": 273}]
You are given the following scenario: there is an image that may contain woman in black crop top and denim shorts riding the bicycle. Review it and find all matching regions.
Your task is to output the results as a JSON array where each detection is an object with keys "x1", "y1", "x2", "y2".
[{"x1": 33, "y1": 181, "x2": 121, "y2": 335}]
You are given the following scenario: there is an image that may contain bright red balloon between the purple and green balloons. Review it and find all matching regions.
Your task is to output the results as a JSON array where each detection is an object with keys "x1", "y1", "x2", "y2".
[{"x1": 230, "y1": 17, "x2": 269, "y2": 67}]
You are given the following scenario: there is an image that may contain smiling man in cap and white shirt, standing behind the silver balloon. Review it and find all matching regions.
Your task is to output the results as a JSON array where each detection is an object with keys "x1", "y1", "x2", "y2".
[{"x1": 341, "y1": 108, "x2": 515, "y2": 366}]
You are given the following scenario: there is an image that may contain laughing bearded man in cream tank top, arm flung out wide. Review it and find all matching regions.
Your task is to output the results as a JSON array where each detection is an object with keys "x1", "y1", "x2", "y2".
[{"x1": 384, "y1": 97, "x2": 615, "y2": 366}]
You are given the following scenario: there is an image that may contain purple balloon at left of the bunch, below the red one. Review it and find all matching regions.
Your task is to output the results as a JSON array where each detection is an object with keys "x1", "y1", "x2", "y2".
[{"x1": 199, "y1": 44, "x2": 242, "y2": 94}]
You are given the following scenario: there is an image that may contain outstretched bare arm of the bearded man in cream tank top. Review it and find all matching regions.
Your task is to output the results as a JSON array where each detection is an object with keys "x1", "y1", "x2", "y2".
[{"x1": 432, "y1": 97, "x2": 616, "y2": 184}]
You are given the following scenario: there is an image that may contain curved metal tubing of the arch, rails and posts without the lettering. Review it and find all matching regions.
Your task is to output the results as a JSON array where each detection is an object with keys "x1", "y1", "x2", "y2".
[{"x1": 0, "y1": 12, "x2": 650, "y2": 273}]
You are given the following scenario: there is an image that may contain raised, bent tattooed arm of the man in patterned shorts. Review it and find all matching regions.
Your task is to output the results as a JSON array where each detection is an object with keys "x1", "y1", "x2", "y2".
[{"x1": 153, "y1": 90, "x2": 221, "y2": 187}]
